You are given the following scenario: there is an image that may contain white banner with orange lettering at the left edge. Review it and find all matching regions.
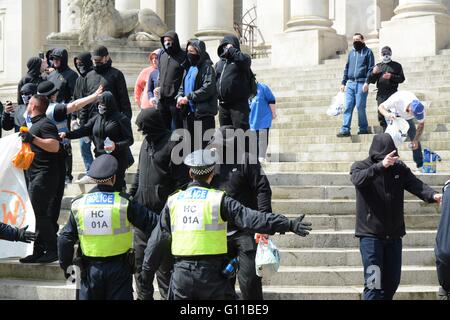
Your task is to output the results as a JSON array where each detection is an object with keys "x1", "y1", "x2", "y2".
[{"x1": 0, "y1": 134, "x2": 36, "y2": 258}]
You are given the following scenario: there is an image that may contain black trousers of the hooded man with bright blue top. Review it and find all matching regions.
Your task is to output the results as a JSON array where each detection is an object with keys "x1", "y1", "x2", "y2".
[{"x1": 183, "y1": 113, "x2": 216, "y2": 151}]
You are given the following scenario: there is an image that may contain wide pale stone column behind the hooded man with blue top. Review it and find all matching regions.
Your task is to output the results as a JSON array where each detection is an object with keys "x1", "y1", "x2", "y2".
[{"x1": 195, "y1": 0, "x2": 235, "y2": 61}]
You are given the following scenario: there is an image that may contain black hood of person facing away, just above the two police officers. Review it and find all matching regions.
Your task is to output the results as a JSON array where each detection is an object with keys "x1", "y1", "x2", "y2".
[{"x1": 136, "y1": 109, "x2": 170, "y2": 142}]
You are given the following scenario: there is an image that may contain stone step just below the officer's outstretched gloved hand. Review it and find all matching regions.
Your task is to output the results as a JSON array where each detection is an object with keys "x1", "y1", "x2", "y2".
[{"x1": 272, "y1": 231, "x2": 436, "y2": 249}]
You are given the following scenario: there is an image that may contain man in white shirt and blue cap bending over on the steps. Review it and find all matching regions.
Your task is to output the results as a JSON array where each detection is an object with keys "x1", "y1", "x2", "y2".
[{"x1": 378, "y1": 91, "x2": 425, "y2": 171}]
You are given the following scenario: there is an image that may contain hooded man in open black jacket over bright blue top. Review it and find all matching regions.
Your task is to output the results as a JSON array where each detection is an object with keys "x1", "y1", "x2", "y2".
[{"x1": 177, "y1": 39, "x2": 217, "y2": 151}]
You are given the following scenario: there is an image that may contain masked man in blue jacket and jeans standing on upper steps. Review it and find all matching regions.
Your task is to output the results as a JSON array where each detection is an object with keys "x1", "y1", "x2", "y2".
[{"x1": 337, "y1": 33, "x2": 375, "y2": 138}]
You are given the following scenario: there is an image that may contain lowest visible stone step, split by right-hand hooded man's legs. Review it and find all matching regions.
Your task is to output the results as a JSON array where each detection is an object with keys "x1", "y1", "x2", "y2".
[{"x1": 263, "y1": 285, "x2": 439, "y2": 300}]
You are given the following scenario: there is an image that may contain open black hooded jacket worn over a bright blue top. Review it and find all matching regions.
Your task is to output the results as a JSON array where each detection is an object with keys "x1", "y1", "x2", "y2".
[{"x1": 178, "y1": 40, "x2": 217, "y2": 117}]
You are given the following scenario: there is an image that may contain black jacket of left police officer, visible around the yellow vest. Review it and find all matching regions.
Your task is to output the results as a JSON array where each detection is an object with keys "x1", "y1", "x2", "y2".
[{"x1": 58, "y1": 185, "x2": 158, "y2": 270}]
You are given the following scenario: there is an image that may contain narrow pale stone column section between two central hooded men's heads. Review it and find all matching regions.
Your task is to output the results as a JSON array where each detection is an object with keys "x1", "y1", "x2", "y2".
[{"x1": 175, "y1": 0, "x2": 198, "y2": 46}]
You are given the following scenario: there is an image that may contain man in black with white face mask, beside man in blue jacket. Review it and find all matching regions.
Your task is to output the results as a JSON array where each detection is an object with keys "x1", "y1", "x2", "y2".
[{"x1": 369, "y1": 47, "x2": 405, "y2": 131}]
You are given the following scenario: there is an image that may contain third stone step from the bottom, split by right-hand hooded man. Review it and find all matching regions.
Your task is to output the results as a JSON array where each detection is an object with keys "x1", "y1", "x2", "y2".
[{"x1": 279, "y1": 248, "x2": 436, "y2": 267}]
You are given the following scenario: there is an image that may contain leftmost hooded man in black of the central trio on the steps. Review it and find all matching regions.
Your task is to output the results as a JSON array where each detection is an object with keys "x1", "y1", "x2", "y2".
[{"x1": 158, "y1": 31, "x2": 187, "y2": 129}]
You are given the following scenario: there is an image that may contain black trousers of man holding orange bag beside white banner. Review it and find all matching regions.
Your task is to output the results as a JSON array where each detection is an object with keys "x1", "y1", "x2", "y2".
[{"x1": 28, "y1": 170, "x2": 60, "y2": 254}]
